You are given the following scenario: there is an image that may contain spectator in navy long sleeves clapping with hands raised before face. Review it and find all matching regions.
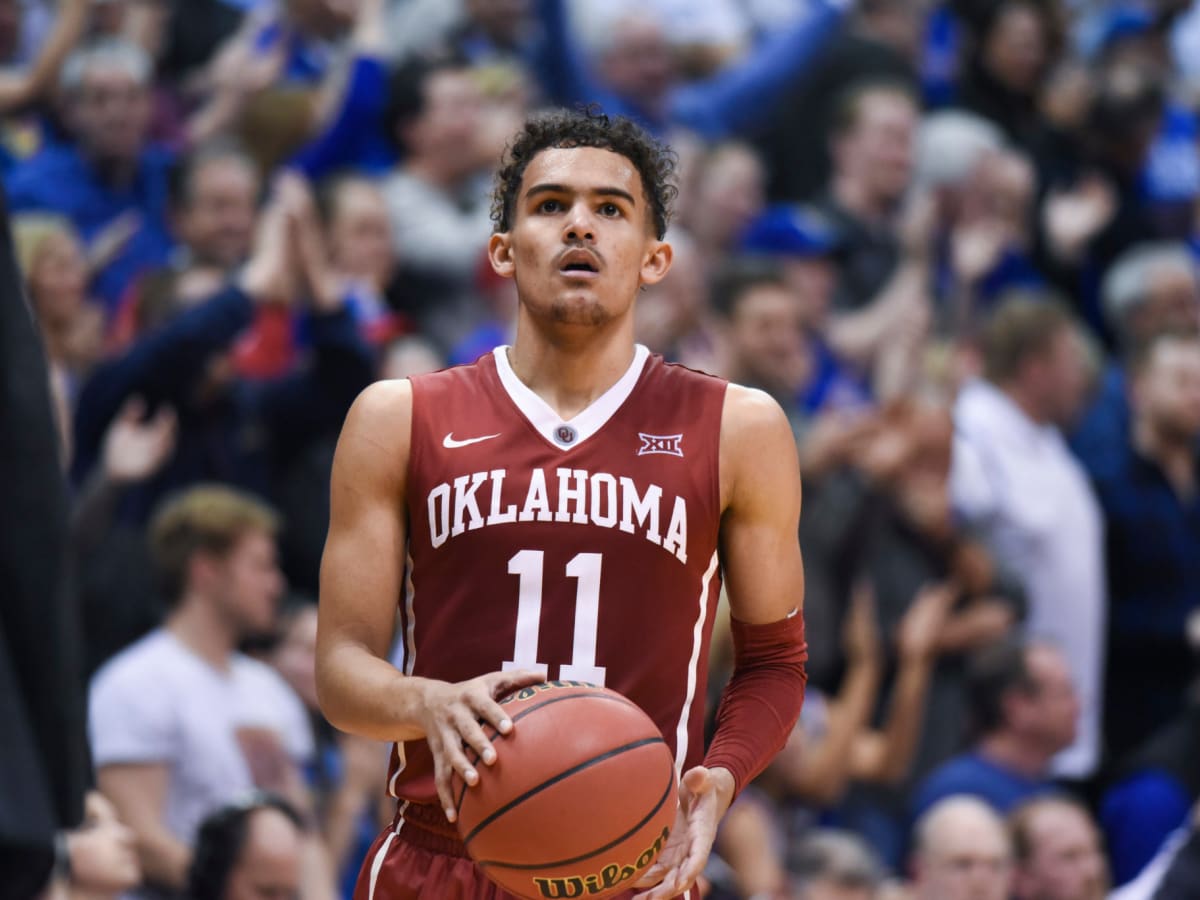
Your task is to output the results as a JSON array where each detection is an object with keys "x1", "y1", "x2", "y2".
[{"x1": 72, "y1": 172, "x2": 374, "y2": 522}]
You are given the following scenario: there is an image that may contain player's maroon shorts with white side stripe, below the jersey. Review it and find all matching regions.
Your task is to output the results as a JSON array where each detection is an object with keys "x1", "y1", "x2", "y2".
[{"x1": 354, "y1": 803, "x2": 697, "y2": 900}]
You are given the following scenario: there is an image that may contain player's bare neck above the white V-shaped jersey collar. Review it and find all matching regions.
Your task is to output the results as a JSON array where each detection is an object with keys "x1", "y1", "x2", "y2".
[{"x1": 509, "y1": 319, "x2": 634, "y2": 420}]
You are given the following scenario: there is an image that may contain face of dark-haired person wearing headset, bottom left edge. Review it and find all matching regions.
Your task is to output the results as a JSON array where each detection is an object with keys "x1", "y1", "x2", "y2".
[{"x1": 224, "y1": 809, "x2": 302, "y2": 900}]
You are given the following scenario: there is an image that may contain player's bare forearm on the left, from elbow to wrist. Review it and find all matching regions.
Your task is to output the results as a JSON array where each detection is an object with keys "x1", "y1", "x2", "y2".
[{"x1": 317, "y1": 642, "x2": 433, "y2": 740}]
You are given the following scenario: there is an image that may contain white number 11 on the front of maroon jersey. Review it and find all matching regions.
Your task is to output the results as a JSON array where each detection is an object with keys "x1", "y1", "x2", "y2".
[{"x1": 504, "y1": 550, "x2": 605, "y2": 685}]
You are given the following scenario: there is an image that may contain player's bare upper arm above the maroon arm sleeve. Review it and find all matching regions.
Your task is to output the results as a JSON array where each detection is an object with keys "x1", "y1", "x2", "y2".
[{"x1": 721, "y1": 385, "x2": 804, "y2": 624}]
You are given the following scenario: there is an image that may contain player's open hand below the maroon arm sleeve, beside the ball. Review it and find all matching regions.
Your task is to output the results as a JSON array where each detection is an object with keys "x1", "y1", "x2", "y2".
[{"x1": 636, "y1": 766, "x2": 734, "y2": 900}]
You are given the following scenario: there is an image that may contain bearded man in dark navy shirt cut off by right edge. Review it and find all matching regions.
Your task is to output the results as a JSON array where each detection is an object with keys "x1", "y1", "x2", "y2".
[{"x1": 1096, "y1": 332, "x2": 1200, "y2": 758}]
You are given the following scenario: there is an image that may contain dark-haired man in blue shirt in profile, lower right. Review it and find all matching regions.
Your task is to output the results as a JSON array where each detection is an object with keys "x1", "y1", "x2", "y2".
[{"x1": 912, "y1": 638, "x2": 1079, "y2": 820}]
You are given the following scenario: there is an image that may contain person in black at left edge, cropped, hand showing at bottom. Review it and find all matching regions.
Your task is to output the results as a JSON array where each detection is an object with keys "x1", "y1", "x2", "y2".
[{"x1": 0, "y1": 177, "x2": 138, "y2": 900}]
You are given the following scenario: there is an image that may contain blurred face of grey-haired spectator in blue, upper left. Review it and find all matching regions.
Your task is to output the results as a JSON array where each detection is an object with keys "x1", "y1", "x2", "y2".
[{"x1": 68, "y1": 61, "x2": 151, "y2": 163}]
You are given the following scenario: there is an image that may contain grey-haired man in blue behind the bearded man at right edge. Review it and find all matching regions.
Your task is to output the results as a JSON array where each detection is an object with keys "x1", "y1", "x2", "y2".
[{"x1": 1070, "y1": 241, "x2": 1200, "y2": 478}]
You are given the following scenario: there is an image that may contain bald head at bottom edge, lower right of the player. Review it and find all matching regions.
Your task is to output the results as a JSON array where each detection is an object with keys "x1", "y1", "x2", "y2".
[{"x1": 914, "y1": 800, "x2": 1013, "y2": 900}]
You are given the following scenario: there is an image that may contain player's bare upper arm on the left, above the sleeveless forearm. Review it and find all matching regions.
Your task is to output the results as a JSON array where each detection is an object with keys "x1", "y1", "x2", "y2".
[{"x1": 317, "y1": 382, "x2": 412, "y2": 658}]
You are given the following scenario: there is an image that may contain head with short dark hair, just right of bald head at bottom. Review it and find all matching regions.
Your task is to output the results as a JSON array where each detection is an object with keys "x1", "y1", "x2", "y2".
[{"x1": 1014, "y1": 800, "x2": 1109, "y2": 900}]
